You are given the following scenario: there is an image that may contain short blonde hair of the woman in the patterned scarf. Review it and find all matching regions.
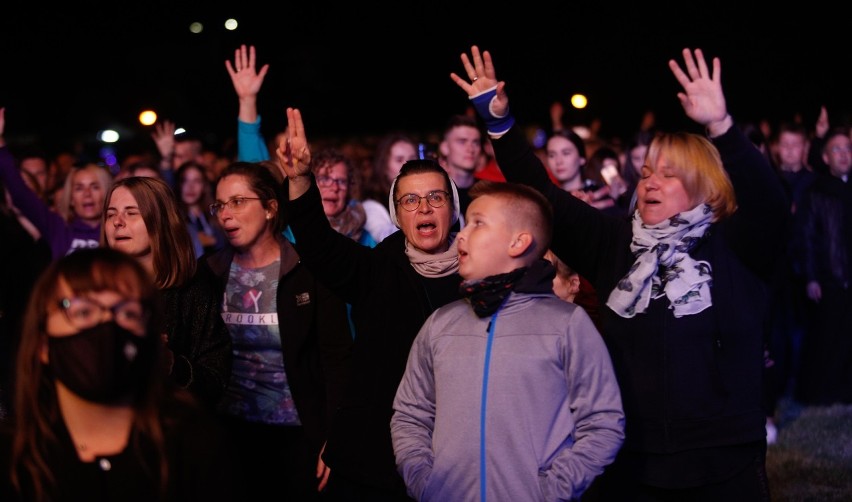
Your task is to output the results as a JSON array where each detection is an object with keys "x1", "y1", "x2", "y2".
[{"x1": 645, "y1": 132, "x2": 737, "y2": 221}]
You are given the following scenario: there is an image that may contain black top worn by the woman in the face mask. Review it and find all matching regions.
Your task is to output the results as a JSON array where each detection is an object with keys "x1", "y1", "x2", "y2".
[{"x1": 0, "y1": 392, "x2": 236, "y2": 502}]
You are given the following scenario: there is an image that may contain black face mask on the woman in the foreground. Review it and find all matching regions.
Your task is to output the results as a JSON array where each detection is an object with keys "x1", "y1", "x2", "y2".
[{"x1": 47, "y1": 321, "x2": 154, "y2": 404}]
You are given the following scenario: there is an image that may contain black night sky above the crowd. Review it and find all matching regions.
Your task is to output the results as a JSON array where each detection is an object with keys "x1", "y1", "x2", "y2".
[{"x1": 0, "y1": 0, "x2": 852, "y2": 157}]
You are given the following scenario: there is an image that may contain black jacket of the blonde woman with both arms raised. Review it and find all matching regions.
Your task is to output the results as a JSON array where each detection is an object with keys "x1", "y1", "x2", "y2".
[{"x1": 492, "y1": 121, "x2": 789, "y2": 487}]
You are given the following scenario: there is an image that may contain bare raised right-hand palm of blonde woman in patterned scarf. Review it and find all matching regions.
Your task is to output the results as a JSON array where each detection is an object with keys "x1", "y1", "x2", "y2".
[{"x1": 669, "y1": 49, "x2": 730, "y2": 135}]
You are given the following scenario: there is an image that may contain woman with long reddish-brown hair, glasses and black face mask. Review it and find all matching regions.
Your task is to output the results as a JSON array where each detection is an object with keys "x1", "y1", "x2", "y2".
[{"x1": 0, "y1": 248, "x2": 235, "y2": 502}]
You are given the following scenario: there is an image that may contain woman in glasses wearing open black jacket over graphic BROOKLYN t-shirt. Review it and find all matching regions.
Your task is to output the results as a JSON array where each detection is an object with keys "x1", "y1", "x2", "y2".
[{"x1": 200, "y1": 162, "x2": 350, "y2": 501}]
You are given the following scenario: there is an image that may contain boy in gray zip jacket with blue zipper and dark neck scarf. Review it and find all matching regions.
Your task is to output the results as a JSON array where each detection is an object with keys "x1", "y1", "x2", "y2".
[{"x1": 390, "y1": 181, "x2": 624, "y2": 502}]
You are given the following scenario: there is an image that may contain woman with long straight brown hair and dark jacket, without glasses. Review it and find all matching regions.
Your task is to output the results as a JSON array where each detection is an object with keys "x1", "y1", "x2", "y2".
[{"x1": 101, "y1": 176, "x2": 232, "y2": 410}]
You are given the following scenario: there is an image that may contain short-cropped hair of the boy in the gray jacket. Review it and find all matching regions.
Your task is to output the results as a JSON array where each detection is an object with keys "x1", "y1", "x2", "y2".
[{"x1": 469, "y1": 180, "x2": 553, "y2": 258}]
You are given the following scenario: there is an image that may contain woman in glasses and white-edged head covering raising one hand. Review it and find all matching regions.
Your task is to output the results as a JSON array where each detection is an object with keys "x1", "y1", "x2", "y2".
[{"x1": 277, "y1": 109, "x2": 461, "y2": 501}]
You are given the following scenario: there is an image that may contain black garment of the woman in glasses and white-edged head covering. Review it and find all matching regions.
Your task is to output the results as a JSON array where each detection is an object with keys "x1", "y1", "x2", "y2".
[{"x1": 285, "y1": 183, "x2": 461, "y2": 495}]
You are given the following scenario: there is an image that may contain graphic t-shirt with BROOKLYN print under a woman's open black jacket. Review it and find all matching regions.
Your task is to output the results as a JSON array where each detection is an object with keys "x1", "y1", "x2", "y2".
[{"x1": 219, "y1": 261, "x2": 300, "y2": 425}]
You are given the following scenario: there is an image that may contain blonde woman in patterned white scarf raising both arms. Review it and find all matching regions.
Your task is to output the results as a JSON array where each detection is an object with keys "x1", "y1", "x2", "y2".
[{"x1": 451, "y1": 46, "x2": 788, "y2": 501}]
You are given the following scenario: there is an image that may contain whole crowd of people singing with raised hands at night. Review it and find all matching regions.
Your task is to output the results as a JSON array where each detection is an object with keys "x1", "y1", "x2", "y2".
[{"x1": 0, "y1": 41, "x2": 852, "y2": 502}]
